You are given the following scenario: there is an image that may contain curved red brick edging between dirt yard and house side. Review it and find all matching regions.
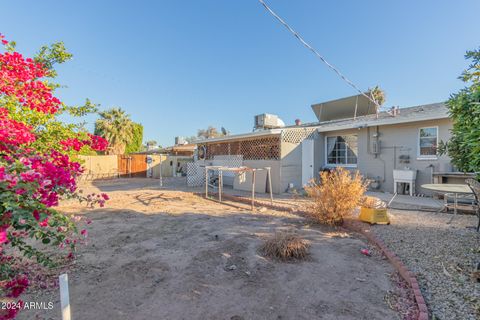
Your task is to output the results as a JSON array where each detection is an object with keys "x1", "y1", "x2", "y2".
[{"x1": 197, "y1": 193, "x2": 429, "y2": 320}]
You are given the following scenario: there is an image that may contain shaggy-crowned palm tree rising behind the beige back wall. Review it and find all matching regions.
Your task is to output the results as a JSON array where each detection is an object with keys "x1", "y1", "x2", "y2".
[{"x1": 95, "y1": 108, "x2": 134, "y2": 154}]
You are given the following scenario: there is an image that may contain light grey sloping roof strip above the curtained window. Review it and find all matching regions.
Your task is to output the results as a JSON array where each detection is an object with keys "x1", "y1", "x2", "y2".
[{"x1": 317, "y1": 103, "x2": 449, "y2": 132}]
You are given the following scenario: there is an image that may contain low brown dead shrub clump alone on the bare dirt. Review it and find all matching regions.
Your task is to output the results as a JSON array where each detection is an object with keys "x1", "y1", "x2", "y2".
[{"x1": 260, "y1": 231, "x2": 310, "y2": 261}]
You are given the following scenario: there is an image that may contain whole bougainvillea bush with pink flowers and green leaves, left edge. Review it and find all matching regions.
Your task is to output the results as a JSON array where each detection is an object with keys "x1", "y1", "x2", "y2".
[{"x1": 0, "y1": 34, "x2": 108, "y2": 319}]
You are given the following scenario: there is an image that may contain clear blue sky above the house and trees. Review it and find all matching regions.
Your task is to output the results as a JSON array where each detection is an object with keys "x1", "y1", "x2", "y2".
[{"x1": 0, "y1": 0, "x2": 480, "y2": 146}]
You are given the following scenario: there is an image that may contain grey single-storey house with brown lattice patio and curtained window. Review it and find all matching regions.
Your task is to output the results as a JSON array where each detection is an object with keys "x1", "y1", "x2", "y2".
[{"x1": 194, "y1": 95, "x2": 452, "y2": 193}]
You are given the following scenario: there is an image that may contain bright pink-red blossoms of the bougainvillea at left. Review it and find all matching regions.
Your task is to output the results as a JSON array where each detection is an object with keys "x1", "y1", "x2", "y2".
[{"x1": 0, "y1": 34, "x2": 108, "y2": 319}]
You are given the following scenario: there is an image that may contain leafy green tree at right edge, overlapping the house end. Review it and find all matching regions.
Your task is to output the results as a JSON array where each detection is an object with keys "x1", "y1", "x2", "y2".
[{"x1": 439, "y1": 48, "x2": 480, "y2": 172}]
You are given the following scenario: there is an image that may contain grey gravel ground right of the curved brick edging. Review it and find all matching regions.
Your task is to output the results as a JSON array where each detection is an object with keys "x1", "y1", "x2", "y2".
[{"x1": 371, "y1": 210, "x2": 480, "y2": 320}]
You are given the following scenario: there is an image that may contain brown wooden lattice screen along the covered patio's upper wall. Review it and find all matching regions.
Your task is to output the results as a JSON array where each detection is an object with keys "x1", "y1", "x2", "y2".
[{"x1": 199, "y1": 136, "x2": 280, "y2": 160}]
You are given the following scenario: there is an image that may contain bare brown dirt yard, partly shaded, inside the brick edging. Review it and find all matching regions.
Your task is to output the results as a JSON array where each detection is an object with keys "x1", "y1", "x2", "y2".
[{"x1": 19, "y1": 179, "x2": 398, "y2": 320}]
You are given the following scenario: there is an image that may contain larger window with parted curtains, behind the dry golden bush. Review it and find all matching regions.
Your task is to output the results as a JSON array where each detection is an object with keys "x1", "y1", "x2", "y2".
[{"x1": 325, "y1": 135, "x2": 358, "y2": 167}]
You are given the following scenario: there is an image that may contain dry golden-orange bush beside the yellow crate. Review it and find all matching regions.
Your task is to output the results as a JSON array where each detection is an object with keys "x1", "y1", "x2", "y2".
[{"x1": 305, "y1": 168, "x2": 369, "y2": 225}]
